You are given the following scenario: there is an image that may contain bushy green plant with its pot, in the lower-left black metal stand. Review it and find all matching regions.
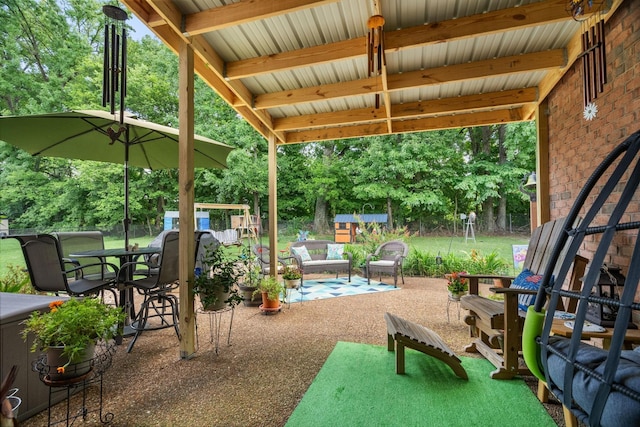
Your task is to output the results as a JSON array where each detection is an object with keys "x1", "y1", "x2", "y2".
[{"x1": 22, "y1": 298, "x2": 125, "y2": 380}]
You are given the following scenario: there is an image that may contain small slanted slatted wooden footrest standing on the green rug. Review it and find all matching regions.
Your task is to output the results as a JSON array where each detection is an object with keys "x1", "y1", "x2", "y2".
[{"x1": 384, "y1": 313, "x2": 469, "y2": 380}]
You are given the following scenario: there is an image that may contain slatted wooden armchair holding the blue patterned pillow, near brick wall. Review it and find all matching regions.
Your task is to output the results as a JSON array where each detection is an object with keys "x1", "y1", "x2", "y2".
[{"x1": 460, "y1": 218, "x2": 587, "y2": 379}]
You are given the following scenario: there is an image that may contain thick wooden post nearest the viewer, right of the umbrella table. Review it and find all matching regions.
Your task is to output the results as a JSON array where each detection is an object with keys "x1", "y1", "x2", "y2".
[{"x1": 178, "y1": 41, "x2": 195, "y2": 359}]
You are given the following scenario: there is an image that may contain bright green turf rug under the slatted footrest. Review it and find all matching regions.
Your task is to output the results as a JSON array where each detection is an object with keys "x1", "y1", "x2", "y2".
[{"x1": 286, "y1": 342, "x2": 556, "y2": 427}]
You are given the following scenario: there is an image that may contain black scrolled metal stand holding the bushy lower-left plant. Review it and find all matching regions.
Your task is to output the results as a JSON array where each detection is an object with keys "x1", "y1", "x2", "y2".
[{"x1": 32, "y1": 341, "x2": 116, "y2": 426}]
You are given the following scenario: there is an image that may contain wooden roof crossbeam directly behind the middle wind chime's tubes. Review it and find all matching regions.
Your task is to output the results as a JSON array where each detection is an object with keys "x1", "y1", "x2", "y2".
[{"x1": 225, "y1": 0, "x2": 571, "y2": 80}]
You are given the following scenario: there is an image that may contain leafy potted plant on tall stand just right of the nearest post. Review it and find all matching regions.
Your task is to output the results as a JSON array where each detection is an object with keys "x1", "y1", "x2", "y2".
[{"x1": 193, "y1": 244, "x2": 245, "y2": 311}]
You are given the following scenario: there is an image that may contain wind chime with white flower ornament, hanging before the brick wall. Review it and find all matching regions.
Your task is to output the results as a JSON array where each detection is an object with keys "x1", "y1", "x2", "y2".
[{"x1": 569, "y1": 0, "x2": 607, "y2": 120}]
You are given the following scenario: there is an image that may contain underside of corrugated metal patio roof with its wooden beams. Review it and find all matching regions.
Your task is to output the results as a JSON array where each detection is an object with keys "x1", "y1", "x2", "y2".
[{"x1": 121, "y1": 0, "x2": 622, "y2": 144}]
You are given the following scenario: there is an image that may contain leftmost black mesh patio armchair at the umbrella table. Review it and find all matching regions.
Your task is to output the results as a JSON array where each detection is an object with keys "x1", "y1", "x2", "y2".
[{"x1": 9, "y1": 234, "x2": 118, "y2": 305}]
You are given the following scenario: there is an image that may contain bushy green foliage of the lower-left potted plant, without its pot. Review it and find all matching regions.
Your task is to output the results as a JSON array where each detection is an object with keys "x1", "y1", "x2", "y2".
[{"x1": 22, "y1": 298, "x2": 125, "y2": 372}]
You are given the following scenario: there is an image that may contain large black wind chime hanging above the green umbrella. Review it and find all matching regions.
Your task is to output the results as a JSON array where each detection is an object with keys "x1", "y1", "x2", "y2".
[{"x1": 102, "y1": 5, "x2": 128, "y2": 125}]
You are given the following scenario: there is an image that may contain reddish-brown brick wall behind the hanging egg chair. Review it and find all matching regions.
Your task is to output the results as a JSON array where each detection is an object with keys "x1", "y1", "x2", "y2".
[{"x1": 548, "y1": 0, "x2": 640, "y2": 272}]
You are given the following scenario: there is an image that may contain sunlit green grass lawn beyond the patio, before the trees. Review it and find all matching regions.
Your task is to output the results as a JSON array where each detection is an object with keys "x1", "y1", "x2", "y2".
[{"x1": 0, "y1": 234, "x2": 529, "y2": 275}]
